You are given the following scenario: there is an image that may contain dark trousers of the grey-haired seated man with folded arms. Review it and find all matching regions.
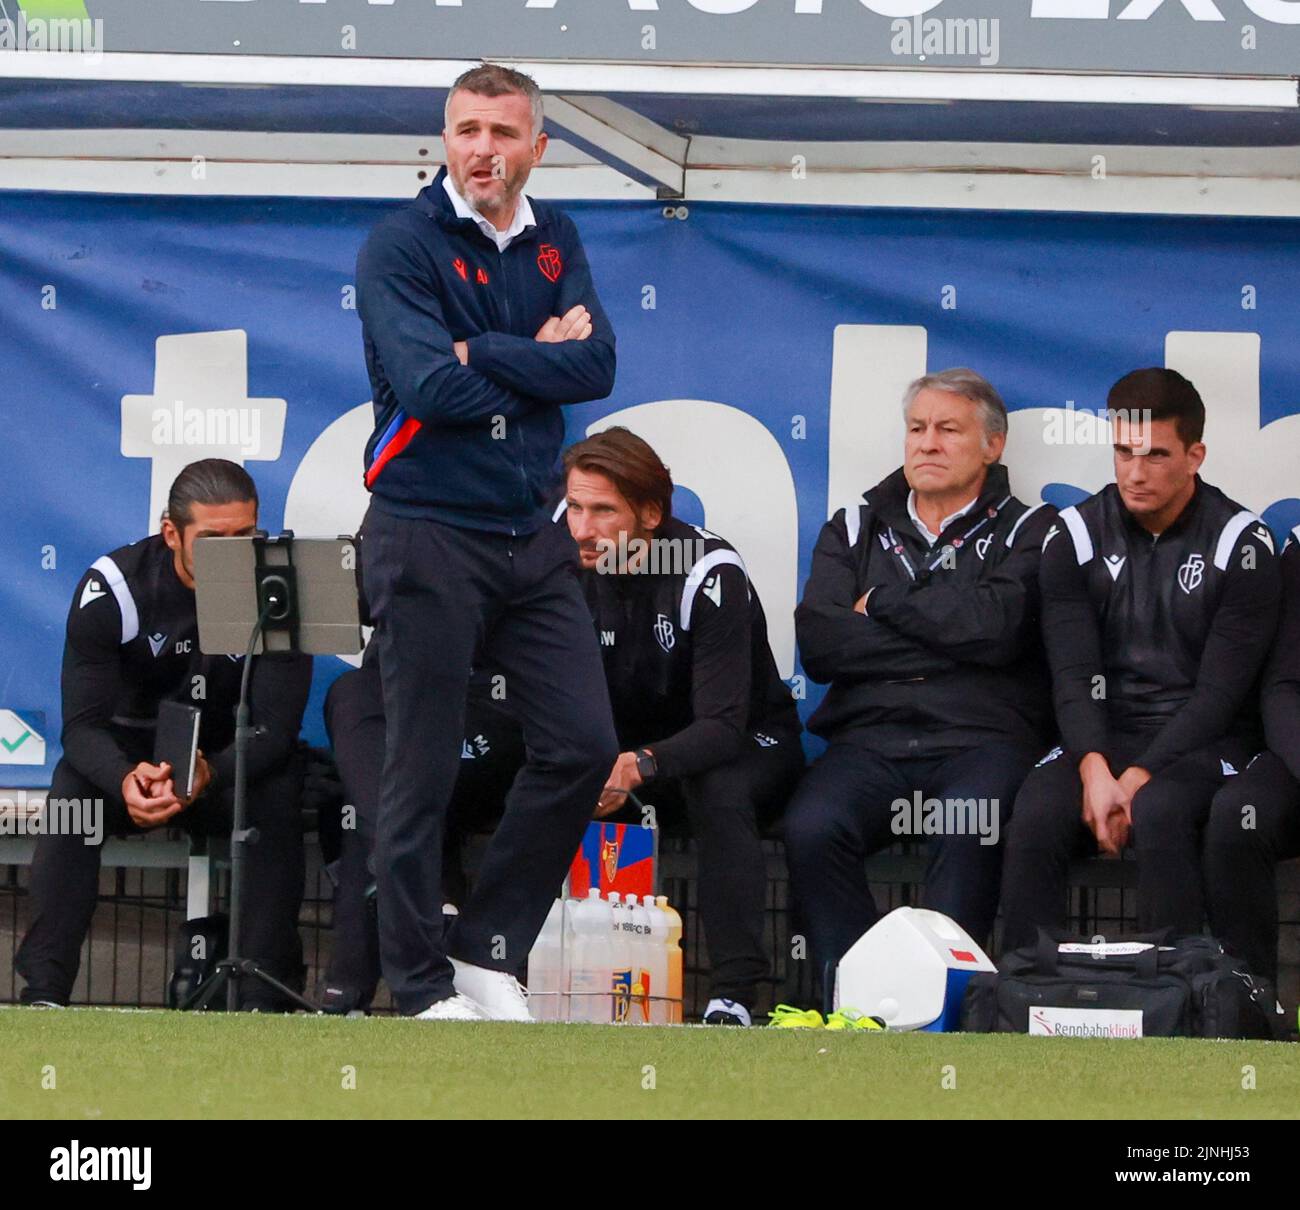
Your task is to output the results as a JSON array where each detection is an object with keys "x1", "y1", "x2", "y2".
[{"x1": 785, "y1": 742, "x2": 1039, "y2": 972}]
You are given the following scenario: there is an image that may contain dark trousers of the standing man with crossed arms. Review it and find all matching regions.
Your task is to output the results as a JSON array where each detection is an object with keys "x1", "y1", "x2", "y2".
[{"x1": 361, "y1": 504, "x2": 618, "y2": 1014}]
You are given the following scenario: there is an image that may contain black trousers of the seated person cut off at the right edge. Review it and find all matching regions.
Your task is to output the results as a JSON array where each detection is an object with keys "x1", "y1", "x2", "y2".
[{"x1": 1203, "y1": 751, "x2": 1300, "y2": 984}]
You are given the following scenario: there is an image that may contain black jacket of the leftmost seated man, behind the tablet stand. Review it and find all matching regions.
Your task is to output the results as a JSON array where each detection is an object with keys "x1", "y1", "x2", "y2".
[{"x1": 62, "y1": 534, "x2": 312, "y2": 794}]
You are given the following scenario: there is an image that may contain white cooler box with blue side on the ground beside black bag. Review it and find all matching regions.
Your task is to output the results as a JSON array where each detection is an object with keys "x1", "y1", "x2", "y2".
[{"x1": 835, "y1": 907, "x2": 996, "y2": 1032}]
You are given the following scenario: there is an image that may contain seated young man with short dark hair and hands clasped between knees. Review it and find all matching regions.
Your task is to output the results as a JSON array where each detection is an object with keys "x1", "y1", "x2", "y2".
[{"x1": 1002, "y1": 368, "x2": 1279, "y2": 950}]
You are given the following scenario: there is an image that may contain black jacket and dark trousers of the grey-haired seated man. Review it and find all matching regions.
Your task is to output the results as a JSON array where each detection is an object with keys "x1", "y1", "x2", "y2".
[{"x1": 785, "y1": 464, "x2": 1056, "y2": 970}]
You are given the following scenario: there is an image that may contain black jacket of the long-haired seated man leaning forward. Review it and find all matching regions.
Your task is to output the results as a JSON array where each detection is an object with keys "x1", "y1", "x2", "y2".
[{"x1": 572, "y1": 512, "x2": 800, "y2": 777}]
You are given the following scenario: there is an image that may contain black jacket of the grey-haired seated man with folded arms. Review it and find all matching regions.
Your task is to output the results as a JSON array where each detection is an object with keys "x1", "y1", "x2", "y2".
[{"x1": 794, "y1": 463, "x2": 1056, "y2": 759}]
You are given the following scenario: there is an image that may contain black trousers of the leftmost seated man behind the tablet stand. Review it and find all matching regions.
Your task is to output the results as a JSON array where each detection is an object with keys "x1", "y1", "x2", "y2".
[{"x1": 14, "y1": 755, "x2": 304, "y2": 1011}]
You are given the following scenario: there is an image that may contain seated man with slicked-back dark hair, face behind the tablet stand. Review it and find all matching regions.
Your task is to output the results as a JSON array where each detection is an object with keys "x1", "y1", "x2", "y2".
[{"x1": 14, "y1": 459, "x2": 312, "y2": 1010}]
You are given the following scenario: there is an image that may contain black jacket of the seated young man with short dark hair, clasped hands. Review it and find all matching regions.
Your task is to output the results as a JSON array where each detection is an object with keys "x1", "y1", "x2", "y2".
[{"x1": 1040, "y1": 476, "x2": 1279, "y2": 773}]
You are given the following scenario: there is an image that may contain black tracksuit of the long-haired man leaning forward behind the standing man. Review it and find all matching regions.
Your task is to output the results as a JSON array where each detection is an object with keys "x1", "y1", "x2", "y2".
[{"x1": 577, "y1": 511, "x2": 803, "y2": 1009}]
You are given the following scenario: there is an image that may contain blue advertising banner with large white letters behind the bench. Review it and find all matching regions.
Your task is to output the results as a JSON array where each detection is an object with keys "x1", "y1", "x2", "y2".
[{"x1": 0, "y1": 183, "x2": 1300, "y2": 788}]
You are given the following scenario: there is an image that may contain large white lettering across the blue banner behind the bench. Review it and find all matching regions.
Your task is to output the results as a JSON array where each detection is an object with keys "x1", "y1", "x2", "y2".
[{"x1": 121, "y1": 324, "x2": 1300, "y2": 677}]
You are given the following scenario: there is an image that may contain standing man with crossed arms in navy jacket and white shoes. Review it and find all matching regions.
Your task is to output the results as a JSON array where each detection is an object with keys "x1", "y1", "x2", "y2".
[{"x1": 356, "y1": 64, "x2": 618, "y2": 1020}]
